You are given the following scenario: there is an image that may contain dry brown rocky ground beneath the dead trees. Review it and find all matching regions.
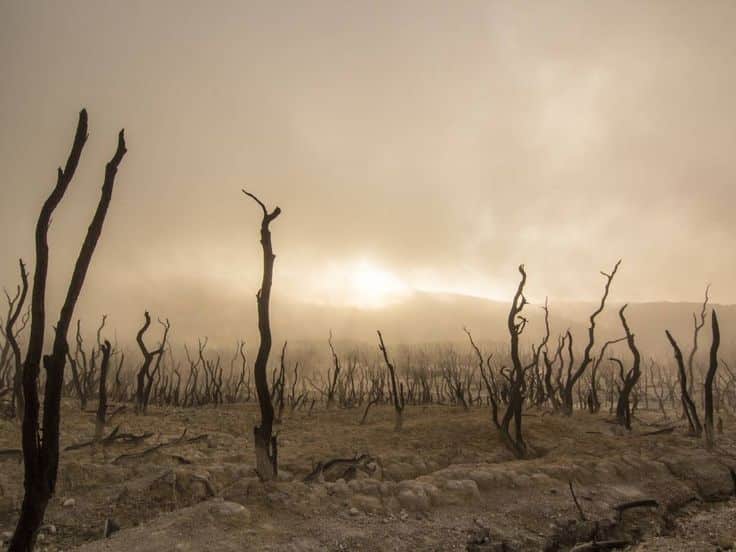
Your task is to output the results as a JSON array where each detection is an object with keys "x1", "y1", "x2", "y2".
[{"x1": 0, "y1": 402, "x2": 736, "y2": 552}]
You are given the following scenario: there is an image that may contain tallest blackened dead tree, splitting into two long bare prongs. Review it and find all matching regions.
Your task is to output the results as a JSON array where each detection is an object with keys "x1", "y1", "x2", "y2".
[{"x1": 9, "y1": 109, "x2": 126, "y2": 552}]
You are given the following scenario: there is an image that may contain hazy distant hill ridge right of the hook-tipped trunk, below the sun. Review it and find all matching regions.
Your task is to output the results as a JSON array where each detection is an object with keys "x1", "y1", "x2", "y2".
[{"x1": 274, "y1": 293, "x2": 736, "y2": 356}]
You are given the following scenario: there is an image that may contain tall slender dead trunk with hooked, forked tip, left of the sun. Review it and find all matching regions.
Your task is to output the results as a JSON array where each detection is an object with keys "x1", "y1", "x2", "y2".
[{"x1": 243, "y1": 190, "x2": 281, "y2": 481}]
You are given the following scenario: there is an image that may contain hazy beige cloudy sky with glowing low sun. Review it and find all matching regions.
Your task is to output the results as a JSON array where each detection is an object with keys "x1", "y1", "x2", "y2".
[{"x1": 0, "y1": 0, "x2": 736, "y2": 342}]
